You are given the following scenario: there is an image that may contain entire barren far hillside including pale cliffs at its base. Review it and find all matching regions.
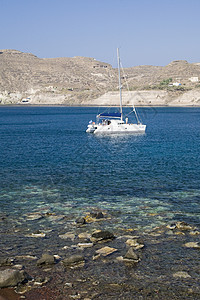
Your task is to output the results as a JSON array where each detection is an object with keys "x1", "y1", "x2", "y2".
[{"x1": 0, "y1": 50, "x2": 200, "y2": 105}]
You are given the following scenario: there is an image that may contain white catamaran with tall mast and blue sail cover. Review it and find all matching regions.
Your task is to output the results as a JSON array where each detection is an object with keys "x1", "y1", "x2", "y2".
[{"x1": 86, "y1": 49, "x2": 146, "y2": 134}]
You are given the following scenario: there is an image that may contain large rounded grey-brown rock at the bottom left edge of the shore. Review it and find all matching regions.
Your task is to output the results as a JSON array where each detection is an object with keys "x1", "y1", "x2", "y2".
[{"x1": 0, "y1": 269, "x2": 28, "y2": 288}]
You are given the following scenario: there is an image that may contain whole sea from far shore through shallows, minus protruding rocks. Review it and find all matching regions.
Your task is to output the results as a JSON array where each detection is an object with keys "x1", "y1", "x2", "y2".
[{"x1": 0, "y1": 107, "x2": 200, "y2": 300}]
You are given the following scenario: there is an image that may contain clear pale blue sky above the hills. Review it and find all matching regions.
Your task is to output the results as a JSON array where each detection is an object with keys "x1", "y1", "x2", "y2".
[{"x1": 0, "y1": 0, "x2": 200, "y2": 67}]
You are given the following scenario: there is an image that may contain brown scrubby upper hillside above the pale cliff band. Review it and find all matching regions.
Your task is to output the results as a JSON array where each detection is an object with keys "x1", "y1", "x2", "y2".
[{"x1": 0, "y1": 50, "x2": 200, "y2": 104}]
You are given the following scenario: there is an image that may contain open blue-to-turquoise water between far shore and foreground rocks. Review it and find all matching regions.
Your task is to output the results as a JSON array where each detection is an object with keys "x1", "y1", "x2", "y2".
[{"x1": 0, "y1": 107, "x2": 200, "y2": 230}]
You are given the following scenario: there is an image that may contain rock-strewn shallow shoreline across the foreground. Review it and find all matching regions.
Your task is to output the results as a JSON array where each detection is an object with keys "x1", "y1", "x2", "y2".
[{"x1": 0, "y1": 210, "x2": 200, "y2": 300}]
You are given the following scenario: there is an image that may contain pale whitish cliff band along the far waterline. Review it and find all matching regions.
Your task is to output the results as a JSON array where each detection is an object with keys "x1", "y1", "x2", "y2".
[{"x1": 0, "y1": 89, "x2": 200, "y2": 107}]
